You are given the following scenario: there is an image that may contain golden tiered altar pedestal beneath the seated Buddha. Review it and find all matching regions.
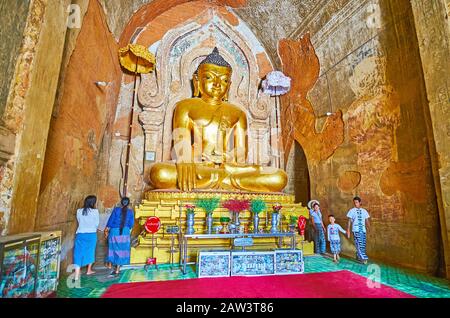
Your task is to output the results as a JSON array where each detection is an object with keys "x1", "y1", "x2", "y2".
[{"x1": 131, "y1": 190, "x2": 314, "y2": 264}]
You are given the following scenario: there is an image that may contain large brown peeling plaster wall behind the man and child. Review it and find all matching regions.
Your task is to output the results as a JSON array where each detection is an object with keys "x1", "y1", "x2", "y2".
[{"x1": 286, "y1": 0, "x2": 440, "y2": 274}]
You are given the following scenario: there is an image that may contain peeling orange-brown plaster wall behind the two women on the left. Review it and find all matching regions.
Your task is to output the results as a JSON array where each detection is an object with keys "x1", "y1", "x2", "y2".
[{"x1": 36, "y1": 0, "x2": 122, "y2": 264}]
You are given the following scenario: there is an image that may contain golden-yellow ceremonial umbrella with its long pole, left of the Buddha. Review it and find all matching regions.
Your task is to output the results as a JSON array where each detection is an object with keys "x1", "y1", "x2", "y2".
[{"x1": 119, "y1": 44, "x2": 156, "y2": 197}]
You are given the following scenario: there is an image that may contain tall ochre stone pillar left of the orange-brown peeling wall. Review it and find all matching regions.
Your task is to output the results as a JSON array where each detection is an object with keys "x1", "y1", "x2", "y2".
[{"x1": 4, "y1": 0, "x2": 71, "y2": 234}]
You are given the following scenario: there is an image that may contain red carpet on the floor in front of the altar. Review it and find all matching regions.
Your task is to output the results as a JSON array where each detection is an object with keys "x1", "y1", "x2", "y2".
[{"x1": 102, "y1": 271, "x2": 413, "y2": 298}]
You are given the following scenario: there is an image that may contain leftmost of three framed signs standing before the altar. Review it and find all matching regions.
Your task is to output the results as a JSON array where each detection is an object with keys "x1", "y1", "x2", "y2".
[{"x1": 197, "y1": 251, "x2": 230, "y2": 278}]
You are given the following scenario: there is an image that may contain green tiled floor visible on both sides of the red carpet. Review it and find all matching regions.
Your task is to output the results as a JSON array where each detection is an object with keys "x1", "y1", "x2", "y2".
[{"x1": 58, "y1": 256, "x2": 450, "y2": 298}]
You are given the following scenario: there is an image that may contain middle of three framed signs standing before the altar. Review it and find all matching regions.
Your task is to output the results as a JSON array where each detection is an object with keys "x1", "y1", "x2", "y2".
[{"x1": 231, "y1": 251, "x2": 275, "y2": 276}]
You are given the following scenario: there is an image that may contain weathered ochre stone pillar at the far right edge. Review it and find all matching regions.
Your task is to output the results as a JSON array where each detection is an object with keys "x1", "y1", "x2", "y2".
[{"x1": 411, "y1": 0, "x2": 450, "y2": 278}]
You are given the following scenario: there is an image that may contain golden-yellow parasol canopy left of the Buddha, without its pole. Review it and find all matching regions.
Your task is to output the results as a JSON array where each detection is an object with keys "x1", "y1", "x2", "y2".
[{"x1": 119, "y1": 44, "x2": 156, "y2": 74}]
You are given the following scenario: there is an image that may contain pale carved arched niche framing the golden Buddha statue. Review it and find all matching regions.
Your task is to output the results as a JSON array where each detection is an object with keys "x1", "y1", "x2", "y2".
[{"x1": 112, "y1": 2, "x2": 280, "y2": 189}]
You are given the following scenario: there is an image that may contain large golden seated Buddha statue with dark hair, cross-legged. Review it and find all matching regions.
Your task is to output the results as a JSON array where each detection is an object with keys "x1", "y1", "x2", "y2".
[{"x1": 149, "y1": 48, "x2": 287, "y2": 192}]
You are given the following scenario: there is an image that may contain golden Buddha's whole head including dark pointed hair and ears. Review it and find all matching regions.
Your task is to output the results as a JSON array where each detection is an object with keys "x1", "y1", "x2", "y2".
[{"x1": 194, "y1": 48, "x2": 232, "y2": 104}]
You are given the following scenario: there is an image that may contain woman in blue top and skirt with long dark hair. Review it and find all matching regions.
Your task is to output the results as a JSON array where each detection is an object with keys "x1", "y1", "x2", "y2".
[{"x1": 105, "y1": 197, "x2": 134, "y2": 276}]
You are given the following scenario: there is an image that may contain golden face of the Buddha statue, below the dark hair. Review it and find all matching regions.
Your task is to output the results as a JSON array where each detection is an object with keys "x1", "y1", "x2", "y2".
[{"x1": 197, "y1": 64, "x2": 231, "y2": 102}]
